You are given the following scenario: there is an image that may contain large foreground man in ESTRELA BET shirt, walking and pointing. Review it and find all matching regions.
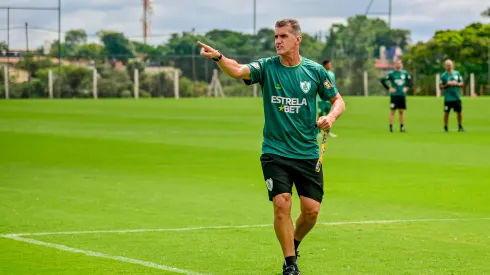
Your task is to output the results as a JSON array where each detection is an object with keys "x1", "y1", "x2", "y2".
[{"x1": 198, "y1": 19, "x2": 345, "y2": 275}]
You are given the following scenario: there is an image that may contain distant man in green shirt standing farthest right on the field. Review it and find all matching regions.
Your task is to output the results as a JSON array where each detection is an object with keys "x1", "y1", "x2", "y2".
[{"x1": 439, "y1": 59, "x2": 464, "y2": 132}]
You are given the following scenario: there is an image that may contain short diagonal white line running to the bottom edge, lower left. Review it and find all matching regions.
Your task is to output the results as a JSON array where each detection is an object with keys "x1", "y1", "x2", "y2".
[{"x1": 2, "y1": 235, "x2": 212, "y2": 275}]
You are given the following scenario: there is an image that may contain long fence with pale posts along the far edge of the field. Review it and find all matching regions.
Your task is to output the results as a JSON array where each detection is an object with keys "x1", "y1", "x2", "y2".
[{"x1": 0, "y1": 55, "x2": 490, "y2": 98}]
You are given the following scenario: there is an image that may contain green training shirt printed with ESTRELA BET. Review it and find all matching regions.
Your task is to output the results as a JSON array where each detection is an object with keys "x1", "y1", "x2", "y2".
[{"x1": 245, "y1": 56, "x2": 338, "y2": 159}]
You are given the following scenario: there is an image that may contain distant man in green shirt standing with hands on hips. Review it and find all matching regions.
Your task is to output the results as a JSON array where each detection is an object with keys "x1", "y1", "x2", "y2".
[{"x1": 381, "y1": 59, "x2": 412, "y2": 132}]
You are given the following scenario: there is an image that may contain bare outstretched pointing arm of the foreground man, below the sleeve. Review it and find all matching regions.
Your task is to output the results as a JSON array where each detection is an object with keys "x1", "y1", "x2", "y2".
[{"x1": 197, "y1": 41, "x2": 250, "y2": 80}]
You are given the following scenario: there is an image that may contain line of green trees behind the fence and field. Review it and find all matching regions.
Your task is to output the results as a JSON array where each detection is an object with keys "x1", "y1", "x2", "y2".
[{"x1": 0, "y1": 8, "x2": 490, "y2": 97}]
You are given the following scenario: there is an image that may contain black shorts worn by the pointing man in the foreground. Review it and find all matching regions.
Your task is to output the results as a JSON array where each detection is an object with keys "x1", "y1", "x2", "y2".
[{"x1": 260, "y1": 154, "x2": 323, "y2": 202}]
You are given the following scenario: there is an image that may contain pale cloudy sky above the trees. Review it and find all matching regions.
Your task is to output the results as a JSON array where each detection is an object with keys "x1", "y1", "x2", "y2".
[{"x1": 0, "y1": 0, "x2": 490, "y2": 48}]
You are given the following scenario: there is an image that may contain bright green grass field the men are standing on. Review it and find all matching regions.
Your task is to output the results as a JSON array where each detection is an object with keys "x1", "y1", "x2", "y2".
[{"x1": 0, "y1": 97, "x2": 490, "y2": 275}]
